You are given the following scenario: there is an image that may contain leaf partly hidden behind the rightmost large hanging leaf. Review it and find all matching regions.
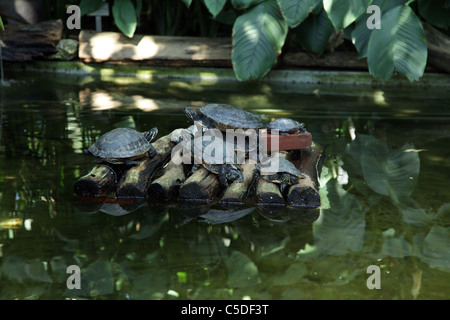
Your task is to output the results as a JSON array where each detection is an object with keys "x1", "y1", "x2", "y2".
[{"x1": 352, "y1": 0, "x2": 406, "y2": 58}]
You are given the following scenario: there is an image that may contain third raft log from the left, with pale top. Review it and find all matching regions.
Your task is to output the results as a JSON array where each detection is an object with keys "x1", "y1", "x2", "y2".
[{"x1": 148, "y1": 150, "x2": 186, "y2": 201}]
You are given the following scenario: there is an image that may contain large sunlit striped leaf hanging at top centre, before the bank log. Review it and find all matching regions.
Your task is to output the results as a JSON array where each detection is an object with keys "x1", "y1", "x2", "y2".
[{"x1": 231, "y1": 0, "x2": 288, "y2": 80}]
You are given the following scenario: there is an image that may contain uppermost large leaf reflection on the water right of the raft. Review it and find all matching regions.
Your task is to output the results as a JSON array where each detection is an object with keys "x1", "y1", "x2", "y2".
[{"x1": 361, "y1": 140, "x2": 420, "y2": 203}]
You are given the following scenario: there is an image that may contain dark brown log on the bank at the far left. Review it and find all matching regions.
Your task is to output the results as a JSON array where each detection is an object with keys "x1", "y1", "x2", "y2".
[{"x1": 2, "y1": 20, "x2": 63, "y2": 62}]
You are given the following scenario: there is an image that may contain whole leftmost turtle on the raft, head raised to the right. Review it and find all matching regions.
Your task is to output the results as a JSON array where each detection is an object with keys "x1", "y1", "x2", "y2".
[{"x1": 86, "y1": 127, "x2": 158, "y2": 165}]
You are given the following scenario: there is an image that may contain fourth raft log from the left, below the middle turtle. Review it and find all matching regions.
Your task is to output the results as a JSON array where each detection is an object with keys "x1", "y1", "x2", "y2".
[{"x1": 178, "y1": 167, "x2": 220, "y2": 203}]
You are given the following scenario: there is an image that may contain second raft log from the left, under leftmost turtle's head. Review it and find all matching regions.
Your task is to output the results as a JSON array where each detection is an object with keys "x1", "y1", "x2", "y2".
[{"x1": 116, "y1": 134, "x2": 174, "y2": 199}]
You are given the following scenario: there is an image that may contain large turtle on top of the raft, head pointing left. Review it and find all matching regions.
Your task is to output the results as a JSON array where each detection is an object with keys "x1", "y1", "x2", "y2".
[{"x1": 184, "y1": 103, "x2": 263, "y2": 131}]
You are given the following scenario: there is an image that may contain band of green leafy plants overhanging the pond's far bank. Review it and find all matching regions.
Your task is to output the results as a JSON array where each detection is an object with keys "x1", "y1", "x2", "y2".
[{"x1": 2, "y1": 0, "x2": 450, "y2": 81}]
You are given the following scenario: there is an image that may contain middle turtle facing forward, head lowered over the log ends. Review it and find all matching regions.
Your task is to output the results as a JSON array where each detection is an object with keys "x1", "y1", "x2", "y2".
[{"x1": 191, "y1": 137, "x2": 244, "y2": 187}]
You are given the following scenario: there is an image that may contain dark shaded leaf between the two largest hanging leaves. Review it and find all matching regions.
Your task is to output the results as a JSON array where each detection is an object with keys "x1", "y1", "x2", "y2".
[{"x1": 296, "y1": 10, "x2": 334, "y2": 53}]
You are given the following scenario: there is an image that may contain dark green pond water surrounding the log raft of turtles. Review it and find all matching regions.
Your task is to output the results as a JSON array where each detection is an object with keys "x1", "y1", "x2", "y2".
[{"x1": 0, "y1": 70, "x2": 450, "y2": 300}]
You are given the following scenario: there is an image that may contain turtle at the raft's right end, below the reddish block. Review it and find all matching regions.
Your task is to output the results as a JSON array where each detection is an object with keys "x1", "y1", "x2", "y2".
[{"x1": 257, "y1": 156, "x2": 306, "y2": 193}]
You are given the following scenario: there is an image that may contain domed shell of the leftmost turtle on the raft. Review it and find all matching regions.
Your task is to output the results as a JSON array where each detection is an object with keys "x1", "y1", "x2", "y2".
[{"x1": 88, "y1": 128, "x2": 151, "y2": 159}]
